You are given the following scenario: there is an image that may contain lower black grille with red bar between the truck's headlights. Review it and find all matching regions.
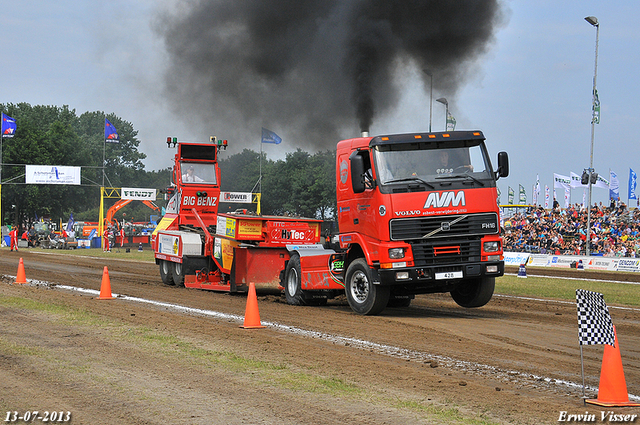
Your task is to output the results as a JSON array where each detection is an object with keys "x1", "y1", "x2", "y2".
[{"x1": 409, "y1": 238, "x2": 481, "y2": 267}]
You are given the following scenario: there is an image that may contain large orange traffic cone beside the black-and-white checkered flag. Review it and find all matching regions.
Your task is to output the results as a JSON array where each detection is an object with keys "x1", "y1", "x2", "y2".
[{"x1": 585, "y1": 326, "x2": 640, "y2": 407}]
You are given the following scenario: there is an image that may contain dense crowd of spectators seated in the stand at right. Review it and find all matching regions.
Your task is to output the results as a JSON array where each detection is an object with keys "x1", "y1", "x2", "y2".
[{"x1": 502, "y1": 202, "x2": 640, "y2": 258}]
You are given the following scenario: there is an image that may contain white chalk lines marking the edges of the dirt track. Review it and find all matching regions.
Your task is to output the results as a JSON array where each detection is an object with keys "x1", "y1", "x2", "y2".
[{"x1": 8, "y1": 279, "x2": 640, "y2": 401}]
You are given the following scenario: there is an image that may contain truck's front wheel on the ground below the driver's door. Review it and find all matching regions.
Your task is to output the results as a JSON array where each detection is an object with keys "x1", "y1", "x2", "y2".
[{"x1": 344, "y1": 258, "x2": 389, "y2": 316}]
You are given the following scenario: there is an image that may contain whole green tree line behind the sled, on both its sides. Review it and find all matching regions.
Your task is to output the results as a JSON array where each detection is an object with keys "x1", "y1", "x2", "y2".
[{"x1": 0, "y1": 103, "x2": 336, "y2": 229}]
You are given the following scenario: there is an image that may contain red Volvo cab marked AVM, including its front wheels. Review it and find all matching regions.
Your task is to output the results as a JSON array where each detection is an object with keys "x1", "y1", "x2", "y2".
[{"x1": 336, "y1": 131, "x2": 509, "y2": 314}]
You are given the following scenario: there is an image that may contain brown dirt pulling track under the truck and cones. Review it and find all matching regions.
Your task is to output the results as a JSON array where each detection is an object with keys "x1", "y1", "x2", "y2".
[{"x1": 0, "y1": 250, "x2": 640, "y2": 424}]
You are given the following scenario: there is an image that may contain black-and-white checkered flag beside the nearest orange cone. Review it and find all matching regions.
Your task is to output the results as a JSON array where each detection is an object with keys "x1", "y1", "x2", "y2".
[{"x1": 576, "y1": 289, "x2": 615, "y2": 347}]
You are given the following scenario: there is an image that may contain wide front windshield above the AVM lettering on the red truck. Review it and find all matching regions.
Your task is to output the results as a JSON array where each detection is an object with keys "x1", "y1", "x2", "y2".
[{"x1": 373, "y1": 144, "x2": 491, "y2": 185}]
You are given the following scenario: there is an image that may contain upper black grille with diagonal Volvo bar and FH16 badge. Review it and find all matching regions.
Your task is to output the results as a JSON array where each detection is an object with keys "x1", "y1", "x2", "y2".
[{"x1": 389, "y1": 213, "x2": 500, "y2": 242}]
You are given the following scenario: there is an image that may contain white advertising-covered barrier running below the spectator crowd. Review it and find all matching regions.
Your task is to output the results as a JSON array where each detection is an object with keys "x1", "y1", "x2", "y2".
[{"x1": 504, "y1": 252, "x2": 640, "y2": 272}]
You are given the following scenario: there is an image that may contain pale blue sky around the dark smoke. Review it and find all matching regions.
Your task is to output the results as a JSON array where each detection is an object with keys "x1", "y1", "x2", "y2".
[{"x1": 0, "y1": 0, "x2": 640, "y2": 202}]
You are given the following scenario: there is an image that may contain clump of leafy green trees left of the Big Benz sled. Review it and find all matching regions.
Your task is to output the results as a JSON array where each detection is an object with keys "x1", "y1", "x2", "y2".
[{"x1": 0, "y1": 103, "x2": 155, "y2": 224}]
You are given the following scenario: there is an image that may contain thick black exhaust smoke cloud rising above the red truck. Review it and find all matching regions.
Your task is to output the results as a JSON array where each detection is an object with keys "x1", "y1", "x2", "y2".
[{"x1": 155, "y1": 0, "x2": 503, "y2": 149}]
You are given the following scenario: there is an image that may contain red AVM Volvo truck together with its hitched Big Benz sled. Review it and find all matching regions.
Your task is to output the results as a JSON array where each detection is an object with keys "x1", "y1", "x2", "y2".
[{"x1": 154, "y1": 131, "x2": 509, "y2": 315}]
